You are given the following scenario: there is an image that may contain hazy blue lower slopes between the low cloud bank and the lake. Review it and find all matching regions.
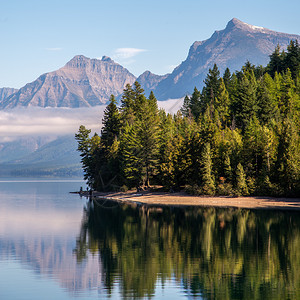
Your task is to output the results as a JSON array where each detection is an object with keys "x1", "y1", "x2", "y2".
[{"x1": 0, "y1": 135, "x2": 82, "y2": 177}]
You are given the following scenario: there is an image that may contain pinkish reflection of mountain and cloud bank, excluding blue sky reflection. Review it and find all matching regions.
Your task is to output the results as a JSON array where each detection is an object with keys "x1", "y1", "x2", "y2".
[{"x1": 0, "y1": 206, "x2": 102, "y2": 299}]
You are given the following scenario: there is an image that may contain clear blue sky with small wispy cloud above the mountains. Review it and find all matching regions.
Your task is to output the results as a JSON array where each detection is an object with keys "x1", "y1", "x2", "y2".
[{"x1": 0, "y1": 0, "x2": 300, "y2": 88}]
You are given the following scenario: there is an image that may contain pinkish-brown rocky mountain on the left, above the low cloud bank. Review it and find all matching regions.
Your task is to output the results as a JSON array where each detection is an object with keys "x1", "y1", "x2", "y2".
[{"x1": 0, "y1": 55, "x2": 136, "y2": 109}]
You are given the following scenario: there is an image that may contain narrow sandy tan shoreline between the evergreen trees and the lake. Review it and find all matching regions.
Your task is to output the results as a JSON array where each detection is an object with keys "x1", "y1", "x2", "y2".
[{"x1": 78, "y1": 191, "x2": 300, "y2": 210}]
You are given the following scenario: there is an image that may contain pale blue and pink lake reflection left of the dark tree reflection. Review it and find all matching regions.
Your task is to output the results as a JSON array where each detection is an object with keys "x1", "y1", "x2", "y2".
[{"x1": 0, "y1": 181, "x2": 103, "y2": 299}]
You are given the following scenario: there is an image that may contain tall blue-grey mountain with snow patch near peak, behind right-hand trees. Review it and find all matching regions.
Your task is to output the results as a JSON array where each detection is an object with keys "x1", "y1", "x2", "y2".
[{"x1": 154, "y1": 18, "x2": 300, "y2": 100}]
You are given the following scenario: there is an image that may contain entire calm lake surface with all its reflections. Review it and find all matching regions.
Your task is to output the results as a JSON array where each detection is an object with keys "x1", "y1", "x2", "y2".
[{"x1": 0, "y1": 179, "x2": 300, "y2": 300}]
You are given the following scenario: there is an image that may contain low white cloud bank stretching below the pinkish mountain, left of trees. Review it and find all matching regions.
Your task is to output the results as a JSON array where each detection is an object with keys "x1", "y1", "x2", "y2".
[{"x1": 0, "y1": 105, "x2": 105, "y2": 143}]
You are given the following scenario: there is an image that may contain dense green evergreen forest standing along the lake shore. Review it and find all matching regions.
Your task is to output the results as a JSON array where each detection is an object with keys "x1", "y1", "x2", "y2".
[{"x1": 76, "y1": 41, "x2": 300, "y2": 196}]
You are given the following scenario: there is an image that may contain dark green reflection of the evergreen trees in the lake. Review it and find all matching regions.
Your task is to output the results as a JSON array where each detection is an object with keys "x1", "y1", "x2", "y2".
[{"x1": 75, "y1": 201, "x2": 300, "y2": 299}]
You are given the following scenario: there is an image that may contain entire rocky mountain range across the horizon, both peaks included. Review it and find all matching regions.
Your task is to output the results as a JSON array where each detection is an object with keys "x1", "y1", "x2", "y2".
[{"x1": 0, "y1": 18, "x2": 300, "y2": 109}]
